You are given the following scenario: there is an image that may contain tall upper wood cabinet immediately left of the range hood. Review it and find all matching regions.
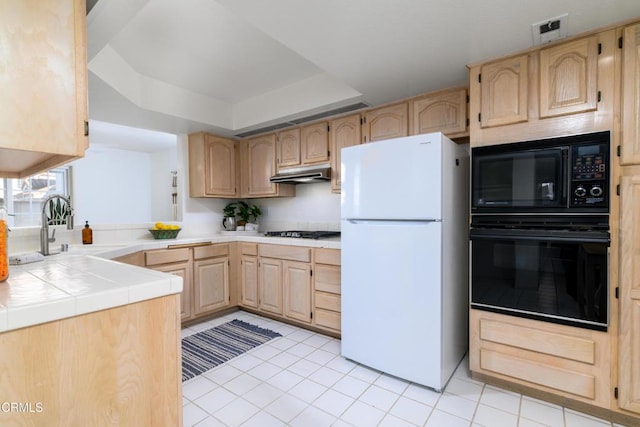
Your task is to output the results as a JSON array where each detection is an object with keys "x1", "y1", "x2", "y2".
[{"x1": 240, "y1": 133, "x2": 296, "y2": 197}]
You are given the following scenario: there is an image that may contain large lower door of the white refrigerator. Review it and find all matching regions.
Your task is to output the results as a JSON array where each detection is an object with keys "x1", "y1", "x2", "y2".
[{"x1": 341, "y1": 220, "x2": 444, "y2": 390}]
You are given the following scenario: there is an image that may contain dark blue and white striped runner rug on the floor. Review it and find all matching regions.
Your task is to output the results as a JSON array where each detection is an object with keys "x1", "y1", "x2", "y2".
[{"x1": 182, "y1": 319, "x2": 282, "y2": 382}]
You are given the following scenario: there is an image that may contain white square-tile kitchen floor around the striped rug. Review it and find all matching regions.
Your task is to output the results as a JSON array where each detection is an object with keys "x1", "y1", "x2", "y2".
[{"x1": 182, "y1": 311, "x2": 632, "y2": 427}]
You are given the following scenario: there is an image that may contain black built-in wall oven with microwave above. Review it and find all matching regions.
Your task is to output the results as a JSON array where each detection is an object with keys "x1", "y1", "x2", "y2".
[{"x1": 469, "y1": 132, "x2": 610, "y2": 330}]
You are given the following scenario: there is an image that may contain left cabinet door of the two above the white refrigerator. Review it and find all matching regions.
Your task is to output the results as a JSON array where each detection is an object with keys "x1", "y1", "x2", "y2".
[{"x1": 364, "y1": 102, "x2": 409, "y2": 142}]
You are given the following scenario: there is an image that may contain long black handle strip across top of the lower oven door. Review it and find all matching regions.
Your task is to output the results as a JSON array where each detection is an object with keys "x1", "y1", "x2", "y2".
[{"x1": 469, "y1": 228, "x2": 611, "y2": 245}]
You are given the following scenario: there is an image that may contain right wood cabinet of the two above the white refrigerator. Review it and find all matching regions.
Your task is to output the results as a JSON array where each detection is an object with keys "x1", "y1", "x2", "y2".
[{"x1": 409, "y1": 87, "x2": 469, "y2": 138}]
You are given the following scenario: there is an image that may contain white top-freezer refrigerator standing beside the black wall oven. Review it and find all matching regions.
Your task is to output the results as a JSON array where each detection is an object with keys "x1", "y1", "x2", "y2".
[{"x1": 341, "y1": 133, "x2": 469, "y2": 391}]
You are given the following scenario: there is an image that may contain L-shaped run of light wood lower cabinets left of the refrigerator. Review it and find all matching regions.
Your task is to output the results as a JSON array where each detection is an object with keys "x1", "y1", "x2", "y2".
[{"x1": 115, "y1": 242, "x2": 341, "y2": 335}]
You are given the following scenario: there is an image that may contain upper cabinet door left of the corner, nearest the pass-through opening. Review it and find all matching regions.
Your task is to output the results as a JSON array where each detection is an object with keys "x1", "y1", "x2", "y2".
[{"x1": 204, "y1": 135, "x2": 236, "y2": 197}]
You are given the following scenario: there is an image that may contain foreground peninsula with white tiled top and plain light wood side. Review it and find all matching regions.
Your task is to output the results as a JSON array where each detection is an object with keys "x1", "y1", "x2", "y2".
[{"x1": 0, "y1": 254, "x2": 183, "y2": 426}]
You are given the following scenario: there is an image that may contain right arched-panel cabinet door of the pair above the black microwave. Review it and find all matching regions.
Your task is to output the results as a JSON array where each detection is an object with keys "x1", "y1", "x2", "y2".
[{"x1": 540, "y1": 36, "x2": 598, "y2": 118}]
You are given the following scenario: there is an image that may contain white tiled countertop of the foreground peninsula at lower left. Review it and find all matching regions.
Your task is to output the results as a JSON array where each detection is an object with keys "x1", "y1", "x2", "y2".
[{"x1": 0, "y1": 254, "x2": 182, "y2": 332}]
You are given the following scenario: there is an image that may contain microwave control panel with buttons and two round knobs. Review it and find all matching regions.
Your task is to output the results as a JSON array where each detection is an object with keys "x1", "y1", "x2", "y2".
[{"x1": 570, "y1": 144, "x2": 609, "y2": 207}]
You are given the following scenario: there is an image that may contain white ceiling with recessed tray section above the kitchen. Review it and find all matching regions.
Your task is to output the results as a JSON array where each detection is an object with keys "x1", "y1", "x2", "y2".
[{"x1": 87, "y1": 0, "x2": 640, "y2": 144}]
